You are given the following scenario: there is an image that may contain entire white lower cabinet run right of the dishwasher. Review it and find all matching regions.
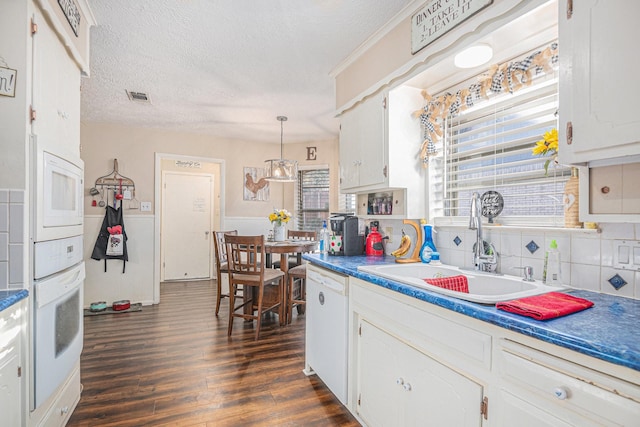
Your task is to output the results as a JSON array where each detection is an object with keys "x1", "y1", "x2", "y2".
[{"x1": 348, "y1": 277, "x2": 640, "y2": 427}]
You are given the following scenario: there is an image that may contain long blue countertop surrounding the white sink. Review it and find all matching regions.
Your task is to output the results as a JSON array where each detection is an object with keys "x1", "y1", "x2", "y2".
[{"x1": 303, "y1": 254, "x2": 640, "y2": 371}]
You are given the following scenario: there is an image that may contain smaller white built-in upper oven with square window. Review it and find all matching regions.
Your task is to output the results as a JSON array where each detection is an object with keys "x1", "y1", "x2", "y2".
[{"x1": 32, "y1": 136, "x2": 84, "y2": 242}]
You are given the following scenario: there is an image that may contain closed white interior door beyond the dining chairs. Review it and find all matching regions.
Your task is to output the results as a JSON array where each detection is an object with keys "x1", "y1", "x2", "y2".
[{"x1": 161, "y1": 172, "x2": 214, "y2": 280}]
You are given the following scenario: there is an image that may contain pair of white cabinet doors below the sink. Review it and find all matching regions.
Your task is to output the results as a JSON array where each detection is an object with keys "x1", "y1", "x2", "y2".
[{"x1": 356, "y1": 320, "x2": 483, "y2": 427}]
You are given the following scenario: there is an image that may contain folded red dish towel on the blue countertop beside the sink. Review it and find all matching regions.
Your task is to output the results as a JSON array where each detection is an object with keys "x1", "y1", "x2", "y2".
[{"x1": 496, "y1": 292, "x2": 593, "y2": 320}]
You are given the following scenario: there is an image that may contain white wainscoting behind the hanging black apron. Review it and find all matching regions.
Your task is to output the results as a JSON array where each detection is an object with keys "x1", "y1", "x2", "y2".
[{"x1": 84, "y1": 214, "x2": 154, "y2": 308}]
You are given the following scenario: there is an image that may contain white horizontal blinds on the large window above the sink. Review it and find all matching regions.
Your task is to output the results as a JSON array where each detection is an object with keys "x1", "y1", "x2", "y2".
[{"x1": 432, "y1": 76, "x2": 570, "y2": 222}]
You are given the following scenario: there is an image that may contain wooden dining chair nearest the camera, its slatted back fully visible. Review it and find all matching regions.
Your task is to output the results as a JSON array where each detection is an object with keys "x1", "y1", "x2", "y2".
[{"x1": 224, "y1": 234, "x2": 286, "y2": 340}]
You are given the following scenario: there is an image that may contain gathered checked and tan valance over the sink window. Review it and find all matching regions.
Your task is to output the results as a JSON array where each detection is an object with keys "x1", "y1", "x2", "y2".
[{"x1": 413, "y1": 42, "x2": 558, "y2": 167}]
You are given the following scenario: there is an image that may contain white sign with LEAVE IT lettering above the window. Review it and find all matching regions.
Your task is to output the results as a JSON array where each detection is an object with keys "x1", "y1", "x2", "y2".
[{"x1": 411, "y1": 0, "x2": 493, "y2": 54}]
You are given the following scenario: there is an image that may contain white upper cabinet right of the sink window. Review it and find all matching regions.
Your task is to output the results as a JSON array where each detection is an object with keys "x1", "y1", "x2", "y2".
[{"x1": 558, "y1": 0, "x2": 640, "y2": 164}]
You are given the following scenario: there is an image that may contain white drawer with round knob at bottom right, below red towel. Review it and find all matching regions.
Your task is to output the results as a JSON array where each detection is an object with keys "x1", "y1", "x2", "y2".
[{"x1": 498, "y1": 340, "x2": 640, "y2": 426}]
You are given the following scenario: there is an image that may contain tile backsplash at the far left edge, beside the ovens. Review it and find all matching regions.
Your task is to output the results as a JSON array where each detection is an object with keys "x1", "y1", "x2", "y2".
[{"x1": 0, "y1": 189, "x2": 25, "y2": 290}]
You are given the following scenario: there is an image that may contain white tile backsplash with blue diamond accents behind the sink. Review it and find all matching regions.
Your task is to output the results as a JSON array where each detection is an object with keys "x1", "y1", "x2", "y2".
[{"x1": 381, "y1": 221, "x2": 640, "y2": 299}]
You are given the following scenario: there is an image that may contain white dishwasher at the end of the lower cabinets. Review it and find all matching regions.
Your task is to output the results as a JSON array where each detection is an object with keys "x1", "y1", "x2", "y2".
[{"x1": 304, "y1": 264, "x2": 349, "y2": 405}]
